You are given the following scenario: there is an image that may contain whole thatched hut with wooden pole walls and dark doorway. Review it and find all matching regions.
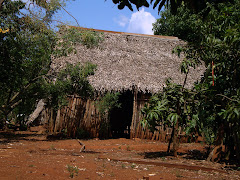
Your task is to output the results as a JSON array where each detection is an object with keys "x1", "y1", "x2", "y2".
[{"x1": 43, "y1": 29, "x2": 205, "y2": 138}]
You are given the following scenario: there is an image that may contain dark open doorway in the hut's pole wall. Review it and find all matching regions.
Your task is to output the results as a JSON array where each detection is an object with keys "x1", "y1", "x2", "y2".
[{"x1": 110, "y1": 91, "x2": 133, "y2": 138}]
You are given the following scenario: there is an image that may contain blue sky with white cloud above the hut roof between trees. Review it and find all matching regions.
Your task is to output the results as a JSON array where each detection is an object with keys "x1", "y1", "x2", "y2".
[{"x1": 55, "y1": 0, "x2": 159, "y2": 34}]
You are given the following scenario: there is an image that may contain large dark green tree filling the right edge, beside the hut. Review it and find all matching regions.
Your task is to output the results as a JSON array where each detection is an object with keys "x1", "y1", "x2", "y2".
[{"x1": 154, "y1": 0, "x2": 240, "y2": 160}]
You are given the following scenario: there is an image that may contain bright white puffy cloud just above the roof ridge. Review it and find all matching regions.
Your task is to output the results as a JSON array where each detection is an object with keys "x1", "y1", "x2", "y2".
[{"x1": 127, "y1": 8, "x2": 156, "y2": 34}]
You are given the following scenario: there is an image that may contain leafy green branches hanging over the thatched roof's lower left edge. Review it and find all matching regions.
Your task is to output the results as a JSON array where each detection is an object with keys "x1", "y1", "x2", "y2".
[{"x1": 42, "y1": 63, "x2": 96, "y2": 110}]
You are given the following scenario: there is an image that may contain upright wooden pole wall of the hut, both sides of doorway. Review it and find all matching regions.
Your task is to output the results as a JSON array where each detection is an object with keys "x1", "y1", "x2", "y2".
[{"x1": 43, "y1": 91, "x2": 195, "y2": 142}]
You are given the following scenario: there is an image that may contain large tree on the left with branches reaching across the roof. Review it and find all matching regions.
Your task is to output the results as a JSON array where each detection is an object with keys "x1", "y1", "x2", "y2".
[{"x1": 0, "y1": 0, "x2": 102, "y2": 127}]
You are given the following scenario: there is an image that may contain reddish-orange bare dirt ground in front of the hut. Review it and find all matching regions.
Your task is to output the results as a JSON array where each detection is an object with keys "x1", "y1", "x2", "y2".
[{"x1": 0, "y1": 127, "x2": 240, "y2": 180}]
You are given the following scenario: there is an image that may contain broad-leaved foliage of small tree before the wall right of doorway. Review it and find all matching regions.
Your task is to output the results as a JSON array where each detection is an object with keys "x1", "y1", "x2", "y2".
[{"x1": 142, "y1": 80, "x2": 192, "y2": 130}]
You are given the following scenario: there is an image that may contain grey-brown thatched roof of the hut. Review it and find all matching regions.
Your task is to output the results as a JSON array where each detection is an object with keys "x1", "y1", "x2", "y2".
[{"x1": 52, "y1": 27, "x2": 205, "y2": 93}]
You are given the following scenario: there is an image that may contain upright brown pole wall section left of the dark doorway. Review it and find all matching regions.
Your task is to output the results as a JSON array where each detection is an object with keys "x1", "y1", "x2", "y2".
[{"x1": 45, "y1": 96, "x2": 101, "y2": 137}]
